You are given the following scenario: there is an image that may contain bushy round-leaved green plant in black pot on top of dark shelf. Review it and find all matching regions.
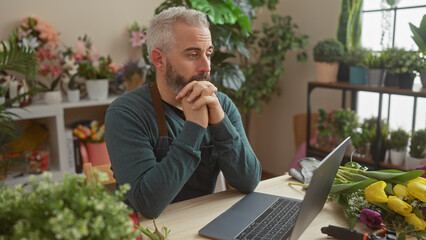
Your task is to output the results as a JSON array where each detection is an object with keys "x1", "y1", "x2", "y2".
[{"x1": 384, "y1": 48, "x2": 421, "y2": 89}]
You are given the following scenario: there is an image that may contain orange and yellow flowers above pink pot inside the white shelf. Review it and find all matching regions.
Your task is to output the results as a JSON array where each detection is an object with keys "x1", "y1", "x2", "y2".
[{"x1": 72, "y1": 120, "x2": 105, "y2": 143}]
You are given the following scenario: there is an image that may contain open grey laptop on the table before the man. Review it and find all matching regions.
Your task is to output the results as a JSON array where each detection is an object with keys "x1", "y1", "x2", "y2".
[{"x1": 199, "y1": 137, "x2": 350, "y2": 240}]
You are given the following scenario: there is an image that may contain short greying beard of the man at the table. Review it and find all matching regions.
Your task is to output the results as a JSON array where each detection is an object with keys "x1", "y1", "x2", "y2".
[{"x1": 166, "y1": 63, "x2": 210, "y2": 94}]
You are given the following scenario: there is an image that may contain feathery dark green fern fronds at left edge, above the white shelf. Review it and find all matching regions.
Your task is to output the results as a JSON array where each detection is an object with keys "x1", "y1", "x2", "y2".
[{"x1": 0, "y1": 40, "x2": 38, "y2": 86}]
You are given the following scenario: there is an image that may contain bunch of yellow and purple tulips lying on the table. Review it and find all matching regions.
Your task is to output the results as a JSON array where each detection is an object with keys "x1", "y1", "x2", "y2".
[{"x1": 329, "y1": 158, "x2": 426, "y2": 239}]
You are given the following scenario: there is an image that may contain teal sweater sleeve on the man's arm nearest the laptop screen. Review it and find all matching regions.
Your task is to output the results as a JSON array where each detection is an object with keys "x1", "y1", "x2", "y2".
[{"x1": 209, "y1": 94, "x2": 262, "y2": 193}]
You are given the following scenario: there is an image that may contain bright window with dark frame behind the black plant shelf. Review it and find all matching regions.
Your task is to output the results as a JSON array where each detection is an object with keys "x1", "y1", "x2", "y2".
[{"x1": 357, "y1": 0, "x2": 426, "y2": 131}]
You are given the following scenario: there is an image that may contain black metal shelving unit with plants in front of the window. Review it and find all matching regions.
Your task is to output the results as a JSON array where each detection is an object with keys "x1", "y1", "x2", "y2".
[{"x1": 306, "y1": 82, "x2": 426, "y2": 169}]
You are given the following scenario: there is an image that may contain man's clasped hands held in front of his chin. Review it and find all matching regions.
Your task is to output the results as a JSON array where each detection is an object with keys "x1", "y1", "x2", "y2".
[{"x1": 176, "y1": 81, "x2": 225, "y2": 128}]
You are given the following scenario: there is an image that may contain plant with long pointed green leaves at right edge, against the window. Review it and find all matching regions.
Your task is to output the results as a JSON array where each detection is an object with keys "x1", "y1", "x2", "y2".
[{"x1": 409, "y1": 14, "x2": 426, "y2": 87}]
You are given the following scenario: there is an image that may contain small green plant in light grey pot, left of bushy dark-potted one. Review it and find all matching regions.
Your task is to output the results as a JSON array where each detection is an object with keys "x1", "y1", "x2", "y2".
[{"x1": 363, "y1": 51, "x2": 387, "y2": 87}]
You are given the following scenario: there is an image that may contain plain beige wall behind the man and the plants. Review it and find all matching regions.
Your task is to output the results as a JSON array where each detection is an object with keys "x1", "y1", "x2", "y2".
[{"x1": 0, "y1": 0, "x2": 341, "y2": 175}]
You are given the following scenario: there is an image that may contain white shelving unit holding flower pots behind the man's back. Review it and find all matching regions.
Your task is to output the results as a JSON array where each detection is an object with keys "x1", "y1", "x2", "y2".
[{"x1": 4, "y1": 96, "x2": 117, "y2": 186}]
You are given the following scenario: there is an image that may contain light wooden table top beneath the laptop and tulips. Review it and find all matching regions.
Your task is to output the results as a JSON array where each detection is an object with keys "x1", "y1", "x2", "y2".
[{"x1": 140, "y1": 175, "x2": 367, "y2": 239}]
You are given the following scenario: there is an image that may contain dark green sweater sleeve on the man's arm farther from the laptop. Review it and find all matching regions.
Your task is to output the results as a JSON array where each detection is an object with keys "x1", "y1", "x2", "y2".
[{"x1": 105, "y1": 108, "x2": 206, "y2": 218}]
